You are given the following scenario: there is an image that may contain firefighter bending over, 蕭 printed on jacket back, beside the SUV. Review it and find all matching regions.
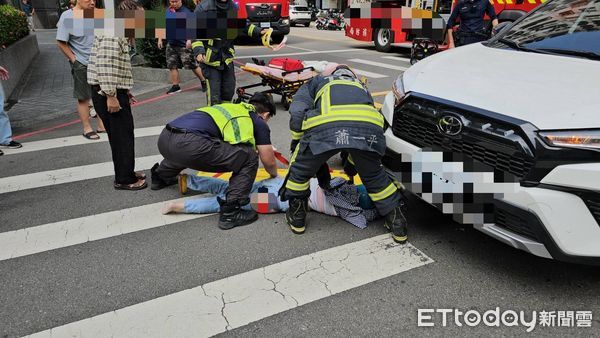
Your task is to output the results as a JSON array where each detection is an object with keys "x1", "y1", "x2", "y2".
[{"x1": 281, "y1": 66, "x2": 407, "y2": 243}]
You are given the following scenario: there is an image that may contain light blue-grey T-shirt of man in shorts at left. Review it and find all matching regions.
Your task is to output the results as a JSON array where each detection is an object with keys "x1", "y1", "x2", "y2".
[{"x1": 56, "y1": 9, "x2": 94, "y2": 66}]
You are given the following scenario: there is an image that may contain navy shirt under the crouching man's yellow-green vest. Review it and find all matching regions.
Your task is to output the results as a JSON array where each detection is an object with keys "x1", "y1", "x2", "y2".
[{"x1": 169, "y1": 111, "x2": 271, "y2": 146}]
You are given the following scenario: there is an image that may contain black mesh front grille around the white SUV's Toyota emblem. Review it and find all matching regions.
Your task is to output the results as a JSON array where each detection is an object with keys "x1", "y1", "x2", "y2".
[{"x1": 392, "y1": 97, "x2": 533, "y2": 181}]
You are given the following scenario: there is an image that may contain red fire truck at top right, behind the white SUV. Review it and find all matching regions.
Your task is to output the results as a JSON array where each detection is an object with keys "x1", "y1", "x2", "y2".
[{"x1": 346, "y1": 0, "x2": 546, "y2": 52}]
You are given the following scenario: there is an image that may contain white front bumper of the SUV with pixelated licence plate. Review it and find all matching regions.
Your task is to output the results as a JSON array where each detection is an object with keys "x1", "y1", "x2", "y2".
[{"x1": 382, "y1": 94, "x2": 600, "y2": 265}]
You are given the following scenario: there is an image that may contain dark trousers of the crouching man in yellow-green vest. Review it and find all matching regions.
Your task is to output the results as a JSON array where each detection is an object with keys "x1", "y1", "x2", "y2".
[{"x1": 156, "y1": 129, "x2": 258, "y2": 205}]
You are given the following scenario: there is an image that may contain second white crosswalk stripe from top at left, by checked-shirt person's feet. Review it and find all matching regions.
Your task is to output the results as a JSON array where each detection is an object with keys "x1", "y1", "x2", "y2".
[{"x1": 0, "y1": 155, "x2": 163, "y2": 194}]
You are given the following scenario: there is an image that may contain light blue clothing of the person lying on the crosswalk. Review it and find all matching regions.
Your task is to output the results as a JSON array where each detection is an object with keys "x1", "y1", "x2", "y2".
[{"x1": 184, "y1": 175, "x2": 289, "y2": 214}]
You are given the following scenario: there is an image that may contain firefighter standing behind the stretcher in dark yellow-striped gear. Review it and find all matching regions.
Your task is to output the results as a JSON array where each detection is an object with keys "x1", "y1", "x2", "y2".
[{"x1": 192, "y1": 0, "x2": 284, "y2": 106}]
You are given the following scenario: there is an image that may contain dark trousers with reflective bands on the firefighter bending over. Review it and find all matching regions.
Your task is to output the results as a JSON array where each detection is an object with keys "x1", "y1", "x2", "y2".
[{"x1": 285, "y1": 143, "x2": 401, "y2": 216}]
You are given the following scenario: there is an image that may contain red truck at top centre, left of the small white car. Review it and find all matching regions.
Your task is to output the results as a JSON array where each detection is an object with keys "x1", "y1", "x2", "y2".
[{"x1": 234, "y1": 0, "x2": 290, "y2": 34}]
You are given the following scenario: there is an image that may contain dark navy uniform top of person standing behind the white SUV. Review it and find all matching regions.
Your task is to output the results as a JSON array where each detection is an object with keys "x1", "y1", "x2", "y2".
[{"x1": 447, "y1": 0, "x2": 496, "y2": 33}]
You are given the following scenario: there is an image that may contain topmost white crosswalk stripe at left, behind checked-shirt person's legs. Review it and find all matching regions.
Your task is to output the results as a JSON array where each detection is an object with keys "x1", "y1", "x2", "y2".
[{"x1": 2, "y1": 126, "x2": 165, "y2": 155}]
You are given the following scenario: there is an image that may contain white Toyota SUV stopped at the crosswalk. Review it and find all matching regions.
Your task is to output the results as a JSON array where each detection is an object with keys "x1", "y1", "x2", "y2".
[{"x1": 382, "y1": 0, "x2": 600, "y2": 264}]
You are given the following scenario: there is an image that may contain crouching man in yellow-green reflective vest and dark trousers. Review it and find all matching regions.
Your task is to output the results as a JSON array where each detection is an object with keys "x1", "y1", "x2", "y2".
[{"x1": 151, "y1": 93, "x2": 277, "y2": 230}]
